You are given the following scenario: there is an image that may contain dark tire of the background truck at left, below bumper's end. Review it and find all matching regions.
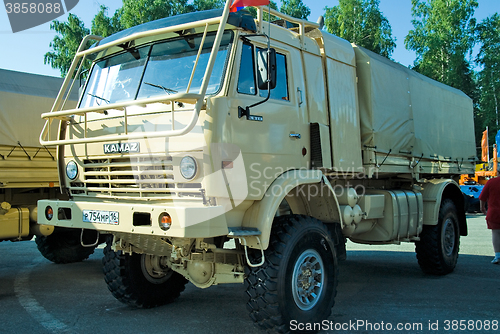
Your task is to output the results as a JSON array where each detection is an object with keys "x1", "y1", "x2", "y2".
[{"x1": 35, "y1": 229, "x2": 96, "y2": 264}]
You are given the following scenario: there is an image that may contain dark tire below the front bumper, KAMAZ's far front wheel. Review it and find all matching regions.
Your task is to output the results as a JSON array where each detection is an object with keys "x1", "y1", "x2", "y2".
[{"x1": 102, "y1": 242, "x2": 188, "y2": 308}]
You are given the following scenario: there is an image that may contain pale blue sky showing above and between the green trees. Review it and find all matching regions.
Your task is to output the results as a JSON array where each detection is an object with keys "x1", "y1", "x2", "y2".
[{"x1": 0, "y1": 0, "x2": 500, "y2": 76}]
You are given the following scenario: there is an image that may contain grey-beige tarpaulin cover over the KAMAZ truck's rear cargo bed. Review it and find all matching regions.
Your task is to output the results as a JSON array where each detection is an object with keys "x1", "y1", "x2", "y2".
[{"x1": 353, "y1": 45, "x2": 476, "y2": 161}]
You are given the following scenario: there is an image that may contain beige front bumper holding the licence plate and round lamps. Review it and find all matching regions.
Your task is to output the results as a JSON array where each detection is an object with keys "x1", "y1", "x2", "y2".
[{"x1": 38, "y1": 200, "x2": 228, "y2": 238}]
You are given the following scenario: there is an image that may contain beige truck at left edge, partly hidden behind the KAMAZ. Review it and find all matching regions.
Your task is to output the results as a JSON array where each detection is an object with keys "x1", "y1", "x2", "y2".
[{"x1": 0, "y1": 69, "x2": 97, "y2": 263}]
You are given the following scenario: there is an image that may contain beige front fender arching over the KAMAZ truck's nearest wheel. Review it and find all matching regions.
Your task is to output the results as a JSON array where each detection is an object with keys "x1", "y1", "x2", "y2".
[{"x1": 243, "y1": 170, "x2": 342, "y2": 249}]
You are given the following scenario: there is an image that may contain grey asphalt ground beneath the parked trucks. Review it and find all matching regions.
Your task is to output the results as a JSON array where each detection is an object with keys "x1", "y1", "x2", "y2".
[{"x1": 0, "y1": 215, "x2": 500, "y2": 334}]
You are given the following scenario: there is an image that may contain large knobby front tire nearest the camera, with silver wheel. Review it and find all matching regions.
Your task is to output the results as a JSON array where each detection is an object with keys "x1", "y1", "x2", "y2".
[{"x1": 245, "y1": 215, "x2": 338, "y2": 333}]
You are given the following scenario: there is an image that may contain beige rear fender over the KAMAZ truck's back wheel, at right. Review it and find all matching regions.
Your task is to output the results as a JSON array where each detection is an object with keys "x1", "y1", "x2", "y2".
[{"x1": 421, "y1": 179, "x2": 467, "y2": 236}]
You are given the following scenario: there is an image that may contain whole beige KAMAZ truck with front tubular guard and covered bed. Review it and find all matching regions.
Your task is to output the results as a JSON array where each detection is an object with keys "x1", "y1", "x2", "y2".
[{"x1": 38, "y1": 0, "x2": 475, "y2": 331}]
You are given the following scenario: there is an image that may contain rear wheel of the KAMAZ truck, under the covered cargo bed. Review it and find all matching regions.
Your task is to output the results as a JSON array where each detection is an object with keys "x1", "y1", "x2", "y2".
[{"x1": 415, "y1": 199, "x2": 460, "y2": 275}]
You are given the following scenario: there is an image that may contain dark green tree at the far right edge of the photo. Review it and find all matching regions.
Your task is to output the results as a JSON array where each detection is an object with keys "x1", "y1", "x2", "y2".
[{"x1": 476, "y1": 13, "x2": 500, "y2": 143}]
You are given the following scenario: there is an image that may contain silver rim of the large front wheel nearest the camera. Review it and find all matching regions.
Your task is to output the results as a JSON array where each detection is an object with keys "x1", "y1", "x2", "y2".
[{"x1": 292, "y1": 249, "x2": 325, "y2": 311}]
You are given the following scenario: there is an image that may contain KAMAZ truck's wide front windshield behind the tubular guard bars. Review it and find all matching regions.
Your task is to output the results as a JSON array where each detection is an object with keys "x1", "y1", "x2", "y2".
[{"x1": 80, "y1": 32, "x2": 233, "y2": 108}]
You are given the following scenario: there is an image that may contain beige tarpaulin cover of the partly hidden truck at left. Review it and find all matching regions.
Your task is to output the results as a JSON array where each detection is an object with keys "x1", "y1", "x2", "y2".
[{"x1": 0, "y1": 69, "x2": 76, "y2": 147}]
